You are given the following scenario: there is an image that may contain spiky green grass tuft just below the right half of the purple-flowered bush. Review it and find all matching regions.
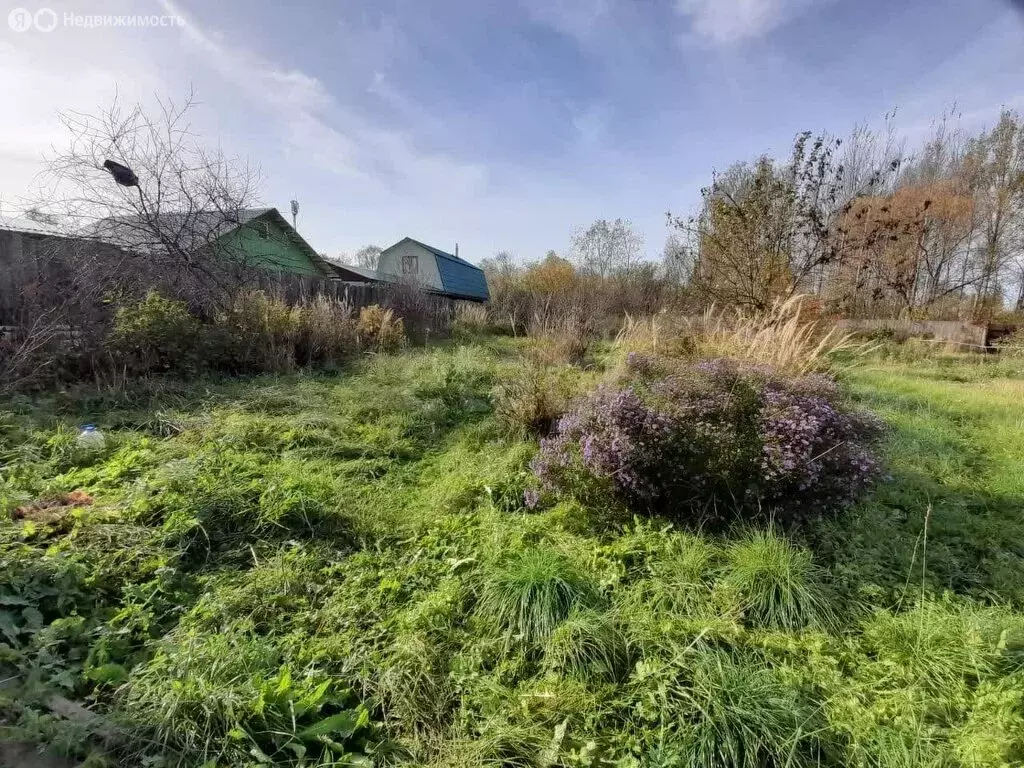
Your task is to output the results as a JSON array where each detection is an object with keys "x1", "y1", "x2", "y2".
[{"x1": 717, "y1": 528, "x2": 836, "y2": 630}]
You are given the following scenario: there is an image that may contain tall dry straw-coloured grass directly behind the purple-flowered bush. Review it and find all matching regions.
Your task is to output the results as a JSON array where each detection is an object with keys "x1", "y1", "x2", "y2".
[{"x1": 615, "y1": 296, "x2": 867, "y2": 375}]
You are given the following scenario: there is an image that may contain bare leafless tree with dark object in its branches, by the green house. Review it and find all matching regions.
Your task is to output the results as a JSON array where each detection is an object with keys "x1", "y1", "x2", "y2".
[{"x1": 40, "y1": 94, "x2": 269, "y2": 307}]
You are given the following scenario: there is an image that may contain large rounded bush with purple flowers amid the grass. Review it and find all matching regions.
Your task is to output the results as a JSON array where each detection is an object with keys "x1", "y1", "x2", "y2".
[{"x1": 527, "y1": 359, "x2": 881, "y2": 519}]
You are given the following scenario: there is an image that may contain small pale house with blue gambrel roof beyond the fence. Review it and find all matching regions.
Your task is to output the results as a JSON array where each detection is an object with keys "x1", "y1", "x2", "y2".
[{"x1": 377, "y1": 238, "x2": 490, "y2": 301}]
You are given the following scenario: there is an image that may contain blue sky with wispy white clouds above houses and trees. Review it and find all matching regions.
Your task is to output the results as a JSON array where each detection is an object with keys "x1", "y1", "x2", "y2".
[{"x1": 0, "y1": 0, "x2": 1024, "y2": 262}]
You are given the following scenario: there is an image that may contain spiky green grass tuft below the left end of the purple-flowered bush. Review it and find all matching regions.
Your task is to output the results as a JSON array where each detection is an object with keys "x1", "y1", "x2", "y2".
[{"x1": 479, "y1": 548, "x2": 597, "y2": 646}]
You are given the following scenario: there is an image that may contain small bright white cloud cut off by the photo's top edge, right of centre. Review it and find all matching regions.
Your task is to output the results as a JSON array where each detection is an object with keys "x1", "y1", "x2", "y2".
[{"x1": 676, "y1": 0, "x2": 814, "y2": 46}]
